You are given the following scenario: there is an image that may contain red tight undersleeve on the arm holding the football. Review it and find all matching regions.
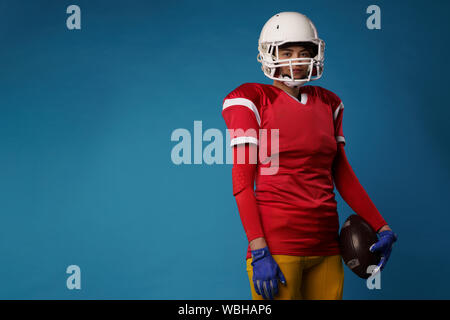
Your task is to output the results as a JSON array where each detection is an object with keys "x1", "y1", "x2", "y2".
[{"x1": 333, "y1": 143, "x2": 387, "y2": 231}]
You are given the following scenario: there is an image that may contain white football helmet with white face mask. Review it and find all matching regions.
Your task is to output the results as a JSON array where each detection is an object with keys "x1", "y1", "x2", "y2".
[{"x1": 257, "y1": 12, "x2": 325, "y2": 87}]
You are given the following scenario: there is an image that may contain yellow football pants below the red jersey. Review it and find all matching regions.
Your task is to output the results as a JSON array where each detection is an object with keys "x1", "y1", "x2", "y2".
[{"x1": 247, "y1": 254, "x2": 344, "y2": 300}]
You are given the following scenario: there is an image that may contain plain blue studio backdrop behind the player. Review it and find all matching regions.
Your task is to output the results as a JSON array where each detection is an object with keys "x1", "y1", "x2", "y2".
[{"x1": 0, "y1": 0, "x2": 450, "y2": 299}]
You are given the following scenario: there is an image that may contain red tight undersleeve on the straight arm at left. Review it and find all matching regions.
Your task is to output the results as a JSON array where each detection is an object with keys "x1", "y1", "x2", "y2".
[{"x1": 232, "y1": 144, "x2": 264, "y2": 242}]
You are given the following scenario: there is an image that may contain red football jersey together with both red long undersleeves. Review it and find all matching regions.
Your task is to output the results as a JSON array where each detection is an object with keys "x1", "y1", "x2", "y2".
[{"x1": 222, "y1": 84, "x2": 386, "y2": 258}]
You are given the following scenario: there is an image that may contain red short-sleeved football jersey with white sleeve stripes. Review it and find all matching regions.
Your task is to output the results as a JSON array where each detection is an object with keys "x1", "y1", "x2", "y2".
[{"x1": 222, "y1": 83, "x2": 345, "y2": 258}]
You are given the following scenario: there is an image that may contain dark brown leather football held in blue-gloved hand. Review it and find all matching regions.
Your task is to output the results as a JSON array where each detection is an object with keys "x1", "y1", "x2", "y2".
[{"x1": 339, "y1": 214, "x2": 381, "y2": 279}]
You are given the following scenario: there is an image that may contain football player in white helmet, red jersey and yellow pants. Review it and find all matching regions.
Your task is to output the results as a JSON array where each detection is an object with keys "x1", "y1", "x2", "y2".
[{"x1": 222, "y1": 12, "x2": 396, "y2": 299}]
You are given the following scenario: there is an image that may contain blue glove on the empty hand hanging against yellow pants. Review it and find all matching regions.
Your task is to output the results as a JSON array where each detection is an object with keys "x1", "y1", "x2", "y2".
[{"x1": 252, "y1": 247, "x2": 286, "y2": 299}]
